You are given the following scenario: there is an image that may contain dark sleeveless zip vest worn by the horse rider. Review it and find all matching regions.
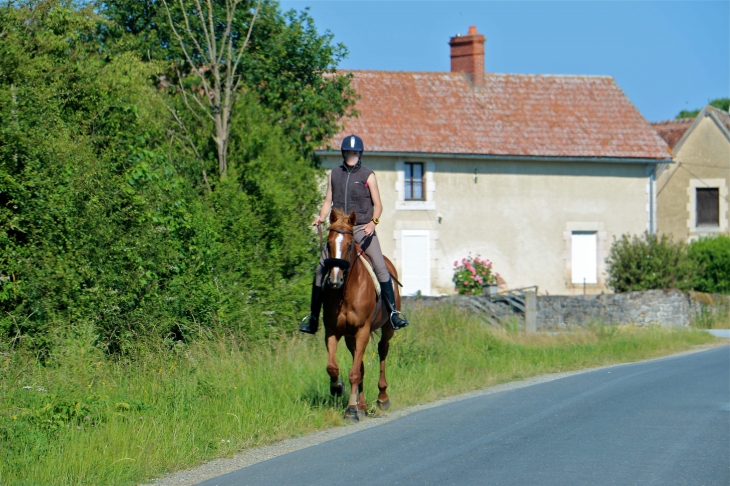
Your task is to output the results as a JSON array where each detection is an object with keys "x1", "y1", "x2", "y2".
[{"x1": 331, "y1": 164, "x2": 373, "y2": 225}]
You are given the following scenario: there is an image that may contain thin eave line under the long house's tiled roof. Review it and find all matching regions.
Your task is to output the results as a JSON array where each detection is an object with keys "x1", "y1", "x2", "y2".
[{"x1": 316, "y1": 150, "x2": 674, "y2": 164}]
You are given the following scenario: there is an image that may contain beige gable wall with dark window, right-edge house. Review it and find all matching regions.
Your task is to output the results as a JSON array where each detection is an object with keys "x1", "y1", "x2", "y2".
[{"x1": 657, "y1": 116, "x2": 730, "y2": 241}]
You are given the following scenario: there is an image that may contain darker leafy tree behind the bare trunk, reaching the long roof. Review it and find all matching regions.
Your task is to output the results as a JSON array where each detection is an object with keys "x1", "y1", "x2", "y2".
[{"x1": 99, "y1": 0, "x2": 356, "y2": 171}]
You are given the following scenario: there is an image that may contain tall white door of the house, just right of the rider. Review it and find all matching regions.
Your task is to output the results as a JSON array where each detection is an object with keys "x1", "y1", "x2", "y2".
[{"x1": 401, "y1": 230, "x2": 431, "y2": 295}]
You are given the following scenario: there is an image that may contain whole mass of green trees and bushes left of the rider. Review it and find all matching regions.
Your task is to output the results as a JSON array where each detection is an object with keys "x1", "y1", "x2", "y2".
[{"x1": 0, "y1": 0, "x2": 353, "y2": 353}]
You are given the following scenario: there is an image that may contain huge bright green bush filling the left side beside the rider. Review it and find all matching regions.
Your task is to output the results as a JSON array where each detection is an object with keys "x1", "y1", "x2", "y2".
[{"x1": 0, "y1": 0, "x2": 344, "y2": 351}]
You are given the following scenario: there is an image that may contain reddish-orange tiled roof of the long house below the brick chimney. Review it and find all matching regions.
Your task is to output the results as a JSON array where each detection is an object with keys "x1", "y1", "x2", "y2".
[{"x1": 330, "y1": 71, "x2": 669, "y2": 159}]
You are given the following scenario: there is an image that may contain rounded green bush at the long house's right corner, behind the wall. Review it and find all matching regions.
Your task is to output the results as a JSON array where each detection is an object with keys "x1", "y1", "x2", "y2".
[{"x1": 606, "y1": 231, "x2": 699, "y2": 292}]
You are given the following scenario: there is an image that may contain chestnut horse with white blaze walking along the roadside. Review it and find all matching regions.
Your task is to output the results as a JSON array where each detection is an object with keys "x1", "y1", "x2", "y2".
[{"x1": 323, "y1": 209, "x2": 400, "y2": 422}]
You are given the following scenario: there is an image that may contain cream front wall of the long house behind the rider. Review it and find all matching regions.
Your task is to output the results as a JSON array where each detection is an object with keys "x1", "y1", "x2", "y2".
[{"x1": 325, "y1": 154, "x2": 649, "y2": 295}]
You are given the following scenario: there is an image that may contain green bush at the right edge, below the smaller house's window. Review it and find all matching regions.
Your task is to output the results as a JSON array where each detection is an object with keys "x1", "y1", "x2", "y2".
[{"x1": 688, "y1": 235, "x2": 730, "y2": 294}]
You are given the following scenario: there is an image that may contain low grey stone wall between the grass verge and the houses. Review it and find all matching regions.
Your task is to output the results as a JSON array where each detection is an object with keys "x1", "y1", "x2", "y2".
[{"x1": 404, "y1": 290, "x2": 730, "y2": 330}]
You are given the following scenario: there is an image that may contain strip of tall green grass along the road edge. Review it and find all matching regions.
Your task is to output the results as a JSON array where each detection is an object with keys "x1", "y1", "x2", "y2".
[{"x1": 0, "y1": 309, "x2": 715, "y2": 485}]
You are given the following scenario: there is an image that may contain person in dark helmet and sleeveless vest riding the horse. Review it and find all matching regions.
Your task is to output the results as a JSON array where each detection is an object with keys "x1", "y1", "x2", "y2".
[{"x1": 299, "y1": 135, "x2": 408, "y2": 334}]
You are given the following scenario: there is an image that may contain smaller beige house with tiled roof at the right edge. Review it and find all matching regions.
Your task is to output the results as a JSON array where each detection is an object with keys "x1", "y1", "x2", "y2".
[{"x1": 652, "y1": 106, "x2": 730, "y2": 241}]
